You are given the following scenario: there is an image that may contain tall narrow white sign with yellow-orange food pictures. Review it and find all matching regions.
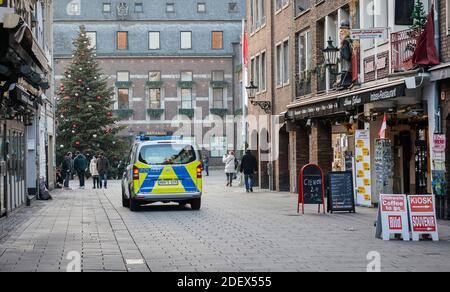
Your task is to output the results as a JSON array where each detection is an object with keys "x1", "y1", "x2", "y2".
[{"x1": 355, "y1": 130, "x2": 372, "y2": 207}]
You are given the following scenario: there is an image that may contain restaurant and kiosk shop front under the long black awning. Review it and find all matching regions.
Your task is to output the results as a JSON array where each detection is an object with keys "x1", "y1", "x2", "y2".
[{"x1": 287, "y1": 80, "x2": 432, "y2": 207}]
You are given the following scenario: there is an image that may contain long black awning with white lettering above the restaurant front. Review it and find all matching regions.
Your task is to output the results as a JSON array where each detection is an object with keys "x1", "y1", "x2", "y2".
[{"x1": 288, "y1": 79, "x2": 406, "y2": 119}]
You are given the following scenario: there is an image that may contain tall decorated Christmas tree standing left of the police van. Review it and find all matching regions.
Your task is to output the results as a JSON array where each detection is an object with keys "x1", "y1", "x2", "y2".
[{"x1": 57, "y1": 26, "x2": 126, "y2": 170}]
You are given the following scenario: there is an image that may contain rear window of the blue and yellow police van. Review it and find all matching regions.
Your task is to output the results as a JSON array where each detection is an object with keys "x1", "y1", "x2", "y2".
[{"x1": 139, "y1": 144, "x2": 196, "y2": 165}]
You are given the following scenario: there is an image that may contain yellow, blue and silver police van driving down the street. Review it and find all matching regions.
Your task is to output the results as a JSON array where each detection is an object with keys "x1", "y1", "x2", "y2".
[{"x1": 122, "y1": 136, "x2": 203, "y2": 211}]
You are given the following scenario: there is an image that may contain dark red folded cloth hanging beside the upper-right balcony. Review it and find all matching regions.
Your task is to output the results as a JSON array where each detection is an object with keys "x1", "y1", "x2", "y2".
[{"x1": 413, "y1": 4, "x2": 440, "y2": 66}]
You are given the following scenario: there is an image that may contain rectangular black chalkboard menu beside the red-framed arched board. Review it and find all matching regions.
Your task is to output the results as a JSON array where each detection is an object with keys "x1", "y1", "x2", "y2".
[{"x1": 328, "y1": 171, "x2": 355, "y2": 213}]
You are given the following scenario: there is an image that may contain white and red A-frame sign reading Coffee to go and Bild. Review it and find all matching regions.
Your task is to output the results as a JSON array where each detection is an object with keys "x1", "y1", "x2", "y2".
[{"x1": 376, "y1": 194, "x2": 410, "y2": 241}]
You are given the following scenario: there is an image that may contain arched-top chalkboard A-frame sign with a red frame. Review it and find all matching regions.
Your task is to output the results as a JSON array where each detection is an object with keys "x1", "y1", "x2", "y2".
[{"x1": 297, "y1": 164, "x2": 325, "y2": 214}]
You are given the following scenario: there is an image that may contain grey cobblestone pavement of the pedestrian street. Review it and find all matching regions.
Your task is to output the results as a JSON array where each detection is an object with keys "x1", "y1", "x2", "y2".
[{"x1": 0, "y1": 173, "x2": 450, "y2": 272}]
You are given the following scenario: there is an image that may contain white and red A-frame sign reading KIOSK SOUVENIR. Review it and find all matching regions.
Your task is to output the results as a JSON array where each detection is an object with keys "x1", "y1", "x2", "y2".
[{"x1": 408, "y1": 195, "x2": 439, "y2": 241}]
